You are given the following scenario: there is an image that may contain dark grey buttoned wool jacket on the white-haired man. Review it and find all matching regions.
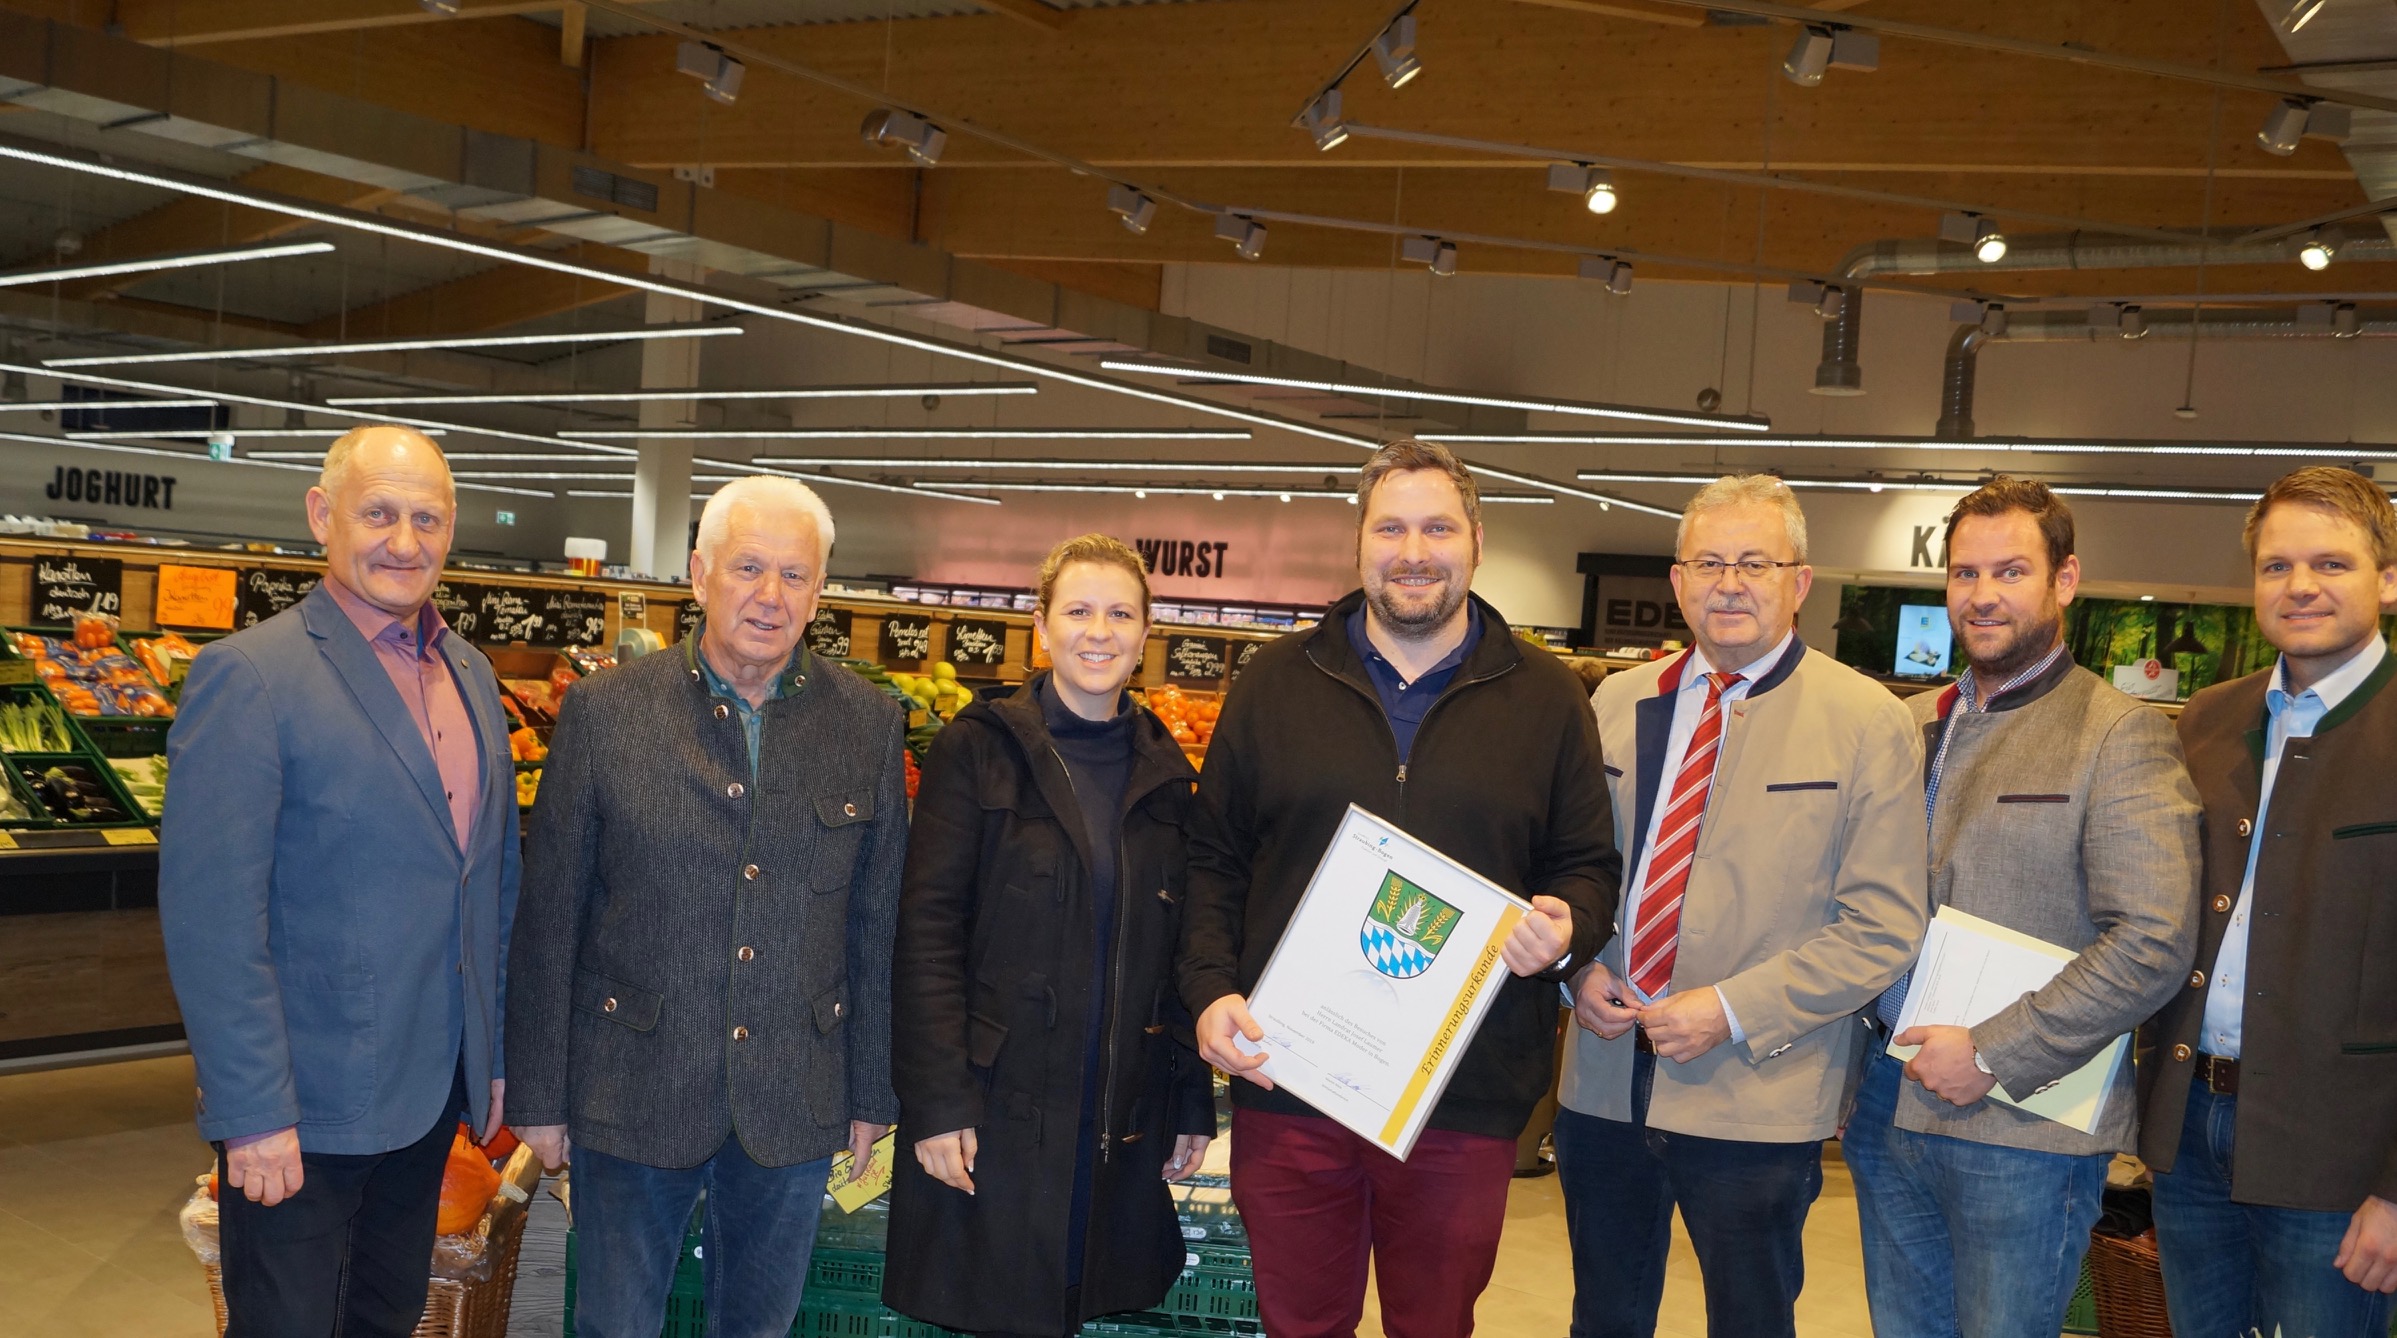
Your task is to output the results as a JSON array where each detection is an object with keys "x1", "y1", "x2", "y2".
[{"x1": 506, "y1": 645, "x2": 906, "y2": 1168}]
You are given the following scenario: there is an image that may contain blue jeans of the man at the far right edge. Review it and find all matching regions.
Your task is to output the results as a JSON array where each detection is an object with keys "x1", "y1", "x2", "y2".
[{"x1": 2155, "y1": 1084, "x2": 2390, "y2": 1338}]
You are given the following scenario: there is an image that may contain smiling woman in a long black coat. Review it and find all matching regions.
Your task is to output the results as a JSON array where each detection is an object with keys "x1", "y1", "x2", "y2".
[{"x1": 882, "y1": 535, "x2": 1215, "y2": 1336}]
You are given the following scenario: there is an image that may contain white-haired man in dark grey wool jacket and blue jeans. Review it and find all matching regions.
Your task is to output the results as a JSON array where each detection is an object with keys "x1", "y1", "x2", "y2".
[{"x1": 506, "y1": 477, "x2": 906, "y2": 1338}]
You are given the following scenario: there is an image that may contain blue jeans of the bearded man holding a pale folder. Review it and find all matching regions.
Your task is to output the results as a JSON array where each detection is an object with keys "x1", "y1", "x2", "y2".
[{"x1": 1838, "y1": 1055, "x2": 2114, "y2": 1338}]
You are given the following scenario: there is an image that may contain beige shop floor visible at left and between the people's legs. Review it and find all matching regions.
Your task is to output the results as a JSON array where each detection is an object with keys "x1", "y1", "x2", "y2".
[{"x1": 0, "y1": 1057, "x2": 1872, "y2": 1338}]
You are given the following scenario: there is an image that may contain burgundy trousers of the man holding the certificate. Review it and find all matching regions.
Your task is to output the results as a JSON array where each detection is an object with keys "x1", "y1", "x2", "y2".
[{"x1": 1232, "y1": 1110, "x2": 1515, "y2": 1338}]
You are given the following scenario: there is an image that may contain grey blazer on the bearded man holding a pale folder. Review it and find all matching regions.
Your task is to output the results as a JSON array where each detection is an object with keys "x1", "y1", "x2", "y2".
[{"x1": 1896, "y1": 662, "x2": 2200, "y2": 1153}]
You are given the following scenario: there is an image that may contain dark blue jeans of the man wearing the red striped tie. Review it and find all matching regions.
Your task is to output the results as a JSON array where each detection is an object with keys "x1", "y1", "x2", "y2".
[{"x1": 1551, "y1": 1055, "x2": 1822, "y2": 1338}]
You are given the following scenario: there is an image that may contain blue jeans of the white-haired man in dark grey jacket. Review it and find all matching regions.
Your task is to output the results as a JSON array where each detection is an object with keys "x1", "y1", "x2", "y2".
[{"x1": 573, "y1": 1134, "x2": 832, "y2": 1338}]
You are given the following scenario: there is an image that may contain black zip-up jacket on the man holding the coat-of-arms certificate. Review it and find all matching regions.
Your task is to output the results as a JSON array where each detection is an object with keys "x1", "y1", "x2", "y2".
[{"x1": 1177, "y1": 592, "x2": 1623, "y2": 1139}]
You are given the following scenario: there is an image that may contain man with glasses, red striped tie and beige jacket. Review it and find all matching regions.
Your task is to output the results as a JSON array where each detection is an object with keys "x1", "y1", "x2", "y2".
[{"x1": 1556, "y1": 475, "x2": 1930, "y2": 1338}]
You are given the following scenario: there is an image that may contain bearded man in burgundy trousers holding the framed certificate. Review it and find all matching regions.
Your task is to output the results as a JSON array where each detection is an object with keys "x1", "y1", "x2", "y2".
[{"x1": 1179, "y1": 441, "x2": 1610, "y2": 1338}]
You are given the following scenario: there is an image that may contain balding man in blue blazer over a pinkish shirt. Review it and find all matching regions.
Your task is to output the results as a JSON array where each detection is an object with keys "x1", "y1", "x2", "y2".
[{"x1": 158, "y1": 427, "x2": 520, "y2": 1338}]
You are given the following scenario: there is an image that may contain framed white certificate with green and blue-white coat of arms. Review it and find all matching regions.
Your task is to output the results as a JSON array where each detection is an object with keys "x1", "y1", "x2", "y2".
[{"x1": 1239, "y1": 803, "x2": 1532, "y2": 1161}]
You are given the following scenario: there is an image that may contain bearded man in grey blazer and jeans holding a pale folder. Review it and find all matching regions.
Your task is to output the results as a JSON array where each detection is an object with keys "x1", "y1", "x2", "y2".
[{"x1": 1841, "y1": 477, "x2": 2198, "y2": 1338}]
